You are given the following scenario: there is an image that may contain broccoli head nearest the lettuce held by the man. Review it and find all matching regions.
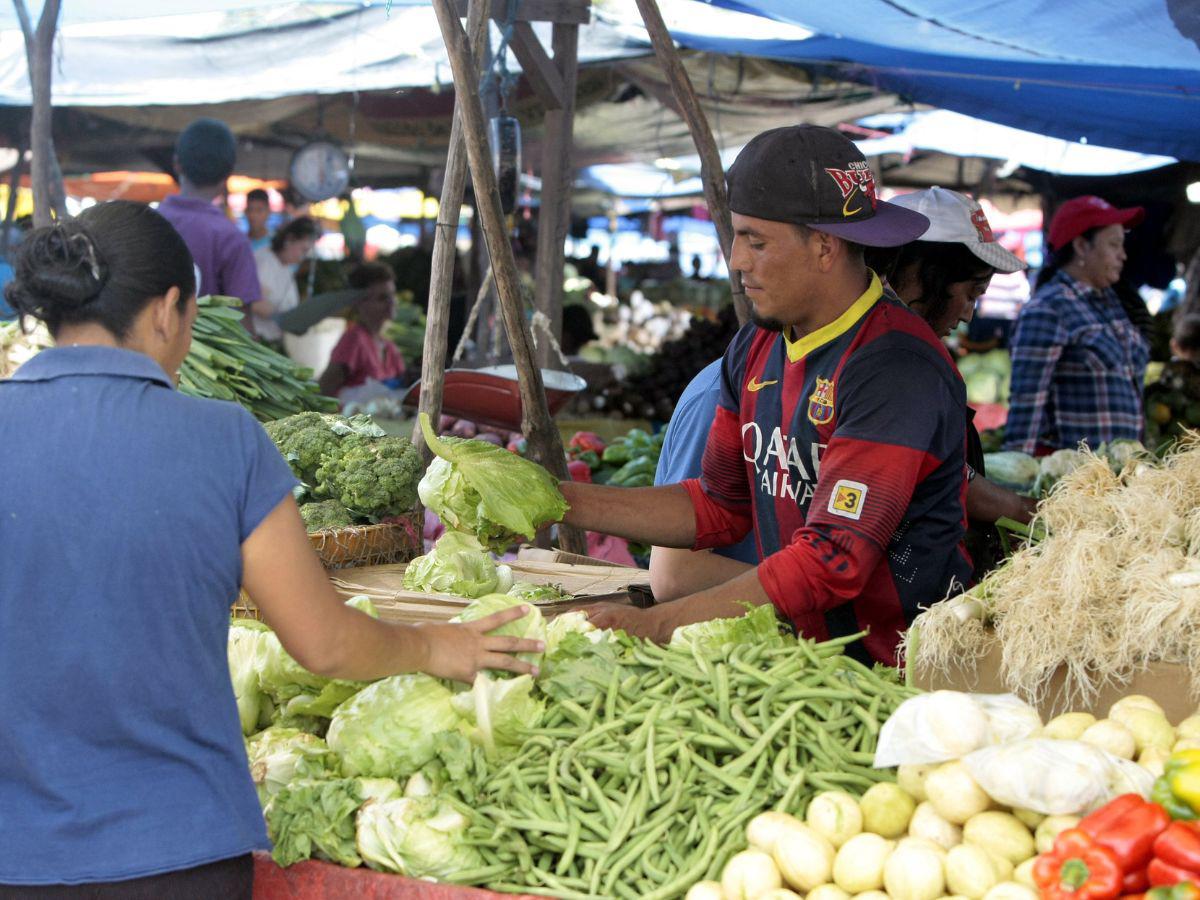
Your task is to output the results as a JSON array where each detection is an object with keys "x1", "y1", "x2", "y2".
[{"x1": 317, "y1": 434, "x2": 422, "y2": 521}]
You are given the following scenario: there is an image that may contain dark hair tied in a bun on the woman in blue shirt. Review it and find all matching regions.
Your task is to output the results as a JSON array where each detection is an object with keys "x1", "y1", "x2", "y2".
[{"x1": 5, "y1": 200, "x2": 196, "y2": 338}]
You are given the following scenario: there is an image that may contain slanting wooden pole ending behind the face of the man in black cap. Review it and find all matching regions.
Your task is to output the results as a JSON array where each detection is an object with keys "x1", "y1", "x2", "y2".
[{"x1": 637, "y1": 0, "x2": 750, "y2": 325}]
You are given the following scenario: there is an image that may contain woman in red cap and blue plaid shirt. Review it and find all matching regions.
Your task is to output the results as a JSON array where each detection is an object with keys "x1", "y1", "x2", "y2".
[{"x1": 1004, "y1": 197, "x2": 1150, "y2": 454}]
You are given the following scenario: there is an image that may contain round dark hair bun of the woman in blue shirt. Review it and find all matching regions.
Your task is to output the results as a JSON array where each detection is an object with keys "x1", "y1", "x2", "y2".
[{"x1": 5, "y1": 221, "x2": 108, "y2": 318}]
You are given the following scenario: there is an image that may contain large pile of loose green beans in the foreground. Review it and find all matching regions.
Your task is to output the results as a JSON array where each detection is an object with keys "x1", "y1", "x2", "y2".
[{"x1": 446, "y1": 638, "x2": 912, "y2": 900}]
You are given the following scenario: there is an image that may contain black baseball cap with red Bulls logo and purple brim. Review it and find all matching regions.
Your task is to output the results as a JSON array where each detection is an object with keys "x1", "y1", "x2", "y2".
[{"x1": 726, "y1": 125, "x2": 929, "y2": 247}]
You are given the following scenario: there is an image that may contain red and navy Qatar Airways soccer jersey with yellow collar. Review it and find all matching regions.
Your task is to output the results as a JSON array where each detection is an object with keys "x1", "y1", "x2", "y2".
[{"x1": 685, "y1": 276, "x2": 971, "y2": 665}]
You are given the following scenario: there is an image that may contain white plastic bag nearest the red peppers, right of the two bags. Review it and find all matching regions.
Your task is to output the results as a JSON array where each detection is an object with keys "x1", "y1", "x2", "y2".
[{"x1": 962, "y1": 738, "x2": 1154, "y2": 816}]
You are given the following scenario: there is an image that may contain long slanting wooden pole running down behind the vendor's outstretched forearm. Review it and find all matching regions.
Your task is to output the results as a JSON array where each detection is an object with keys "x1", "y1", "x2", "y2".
[{"x1": 433, "y1": 0, "x2": 587, "y2": 553}]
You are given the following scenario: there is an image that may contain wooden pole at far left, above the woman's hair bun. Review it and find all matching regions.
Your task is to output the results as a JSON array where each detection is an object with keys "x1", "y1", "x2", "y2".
[{"x1": 13, "y1": 0, "x2": 67, "y2": 228}]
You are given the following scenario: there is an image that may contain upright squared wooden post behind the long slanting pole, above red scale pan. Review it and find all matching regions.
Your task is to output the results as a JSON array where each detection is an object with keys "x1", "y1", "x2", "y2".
[{"x1": 534, "y1": 23, "x2": 580, "y2": 366}]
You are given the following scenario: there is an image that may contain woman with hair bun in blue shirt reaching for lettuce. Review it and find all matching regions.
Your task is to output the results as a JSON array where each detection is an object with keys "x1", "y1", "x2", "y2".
[{"x1": 0, "y1": 202, "x2": 540, "y2": 900}]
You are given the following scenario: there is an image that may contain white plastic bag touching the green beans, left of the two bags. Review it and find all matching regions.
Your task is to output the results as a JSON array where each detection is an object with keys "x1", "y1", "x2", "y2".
[{"x1": 875, "y1": 691, "x2": 1042, "y2": 768}]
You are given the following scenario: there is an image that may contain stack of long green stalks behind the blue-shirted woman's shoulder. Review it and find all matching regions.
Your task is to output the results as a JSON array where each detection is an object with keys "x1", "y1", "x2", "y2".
[{"x1": 179, "y1": 296, "x2": 337, "y2": 422}]
